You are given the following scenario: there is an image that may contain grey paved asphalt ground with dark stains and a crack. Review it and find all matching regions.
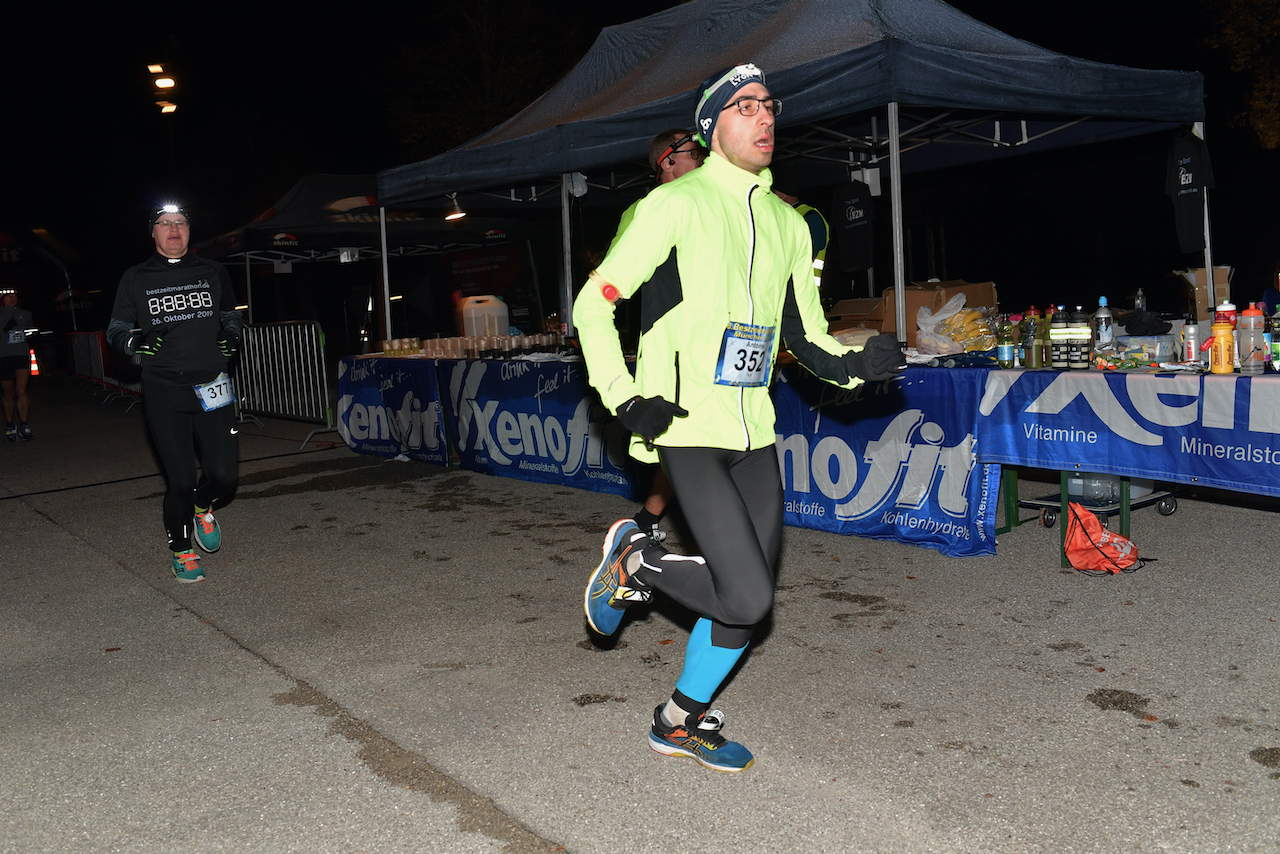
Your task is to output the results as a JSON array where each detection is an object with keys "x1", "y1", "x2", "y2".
[{"x1": 0, "y1": 375, "x2": 1280, "y2": 854}]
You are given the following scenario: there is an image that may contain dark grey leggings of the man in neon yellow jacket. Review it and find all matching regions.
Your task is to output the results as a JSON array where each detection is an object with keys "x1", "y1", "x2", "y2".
[{"x1": 653, "y1": 444, "x2": 782, "y2": 649}]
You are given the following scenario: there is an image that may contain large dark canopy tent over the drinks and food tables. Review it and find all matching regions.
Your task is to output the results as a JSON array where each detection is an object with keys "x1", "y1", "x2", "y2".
[{"x1": 378, "y1": 0, "x2": 1212, "y2": 329}]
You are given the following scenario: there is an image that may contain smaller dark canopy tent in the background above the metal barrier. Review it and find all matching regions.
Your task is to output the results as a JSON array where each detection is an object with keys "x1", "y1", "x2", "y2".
[{"x1": 196, "y1": 173, "x2": 526, "y2": 329}]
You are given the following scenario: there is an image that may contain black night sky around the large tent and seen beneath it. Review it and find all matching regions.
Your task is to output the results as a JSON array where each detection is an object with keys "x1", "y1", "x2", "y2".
[{"x1": 0, "y1": 0, "x2": 1280, "y2": 330}]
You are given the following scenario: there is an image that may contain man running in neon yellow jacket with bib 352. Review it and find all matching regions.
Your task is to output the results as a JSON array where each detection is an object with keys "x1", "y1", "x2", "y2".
[{"x1": 573, "y1": 64, "x2": 905, "y2": 772}]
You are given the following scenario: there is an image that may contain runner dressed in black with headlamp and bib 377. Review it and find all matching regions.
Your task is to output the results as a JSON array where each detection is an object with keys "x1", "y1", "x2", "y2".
[{"x1": 106, "y1": 205, "x2": 243, "y2": 583}]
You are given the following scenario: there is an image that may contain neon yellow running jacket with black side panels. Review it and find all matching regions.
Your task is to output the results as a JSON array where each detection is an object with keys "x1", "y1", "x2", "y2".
[{"x1": 573, "y1": 154, "x2": 861, "y2": 462}]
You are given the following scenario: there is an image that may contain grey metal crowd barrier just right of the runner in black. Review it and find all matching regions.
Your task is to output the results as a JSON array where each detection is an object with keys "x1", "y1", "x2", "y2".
[{"x1": 232, "y1": 321, "x2": 337, "y2": 448}]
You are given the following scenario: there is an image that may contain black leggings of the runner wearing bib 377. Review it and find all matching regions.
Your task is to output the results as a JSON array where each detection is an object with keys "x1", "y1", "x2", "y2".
[{"x1": 142, "y1": 382, "x2": 239, "y2": 552}]
